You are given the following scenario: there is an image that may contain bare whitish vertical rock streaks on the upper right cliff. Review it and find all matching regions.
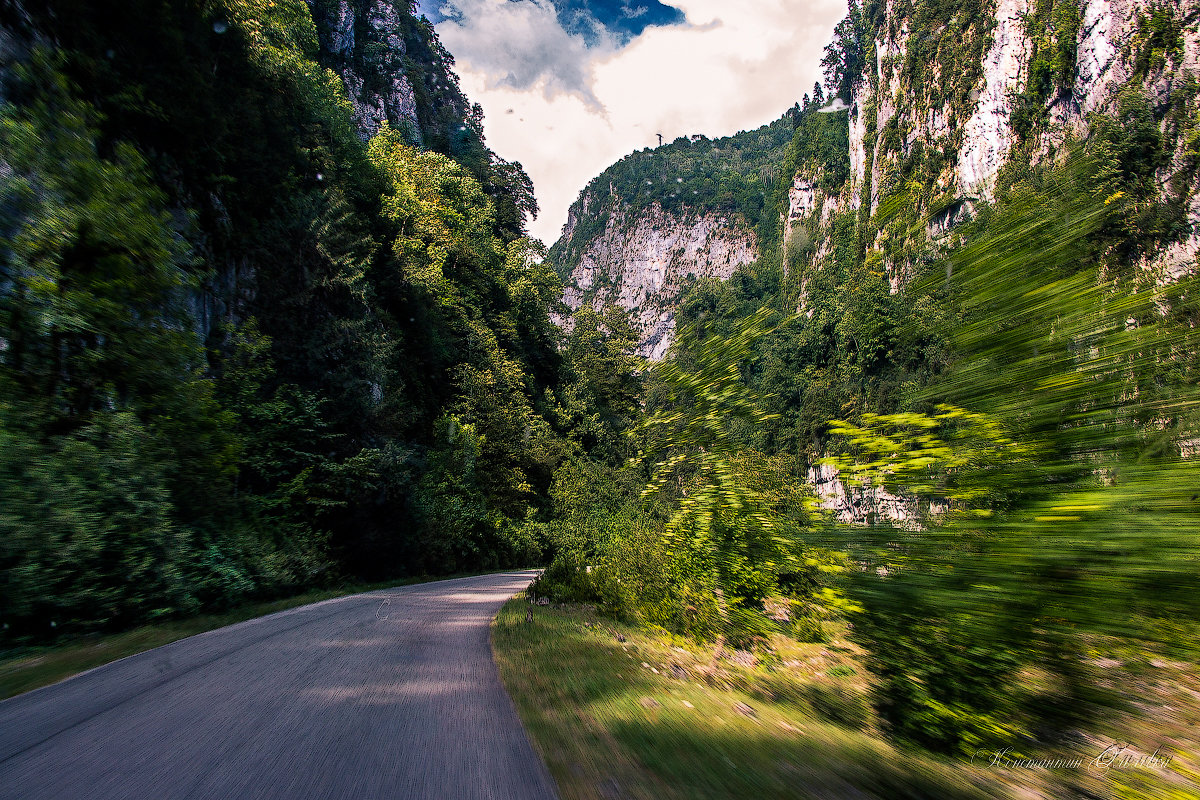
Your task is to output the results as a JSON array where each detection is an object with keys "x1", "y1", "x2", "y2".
[{"x1": 835, "y1": 0, "x2": 1200, "y2": 271}]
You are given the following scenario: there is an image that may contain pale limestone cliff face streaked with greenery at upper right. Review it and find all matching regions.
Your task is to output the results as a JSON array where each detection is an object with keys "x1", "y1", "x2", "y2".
[{"x1": 785, "y1": 0, "x2": 1200, "y2": 278}]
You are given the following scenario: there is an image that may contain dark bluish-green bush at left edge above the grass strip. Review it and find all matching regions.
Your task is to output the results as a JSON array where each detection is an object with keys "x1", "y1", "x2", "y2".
[{"x1": 0, "y1": 405, "x2": 188, "y2": 637}]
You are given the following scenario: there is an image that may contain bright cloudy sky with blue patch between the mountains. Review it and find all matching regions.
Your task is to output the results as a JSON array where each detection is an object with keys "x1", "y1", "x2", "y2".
[{"x1": 419, "y1": 0, "x2": 846, "y2": 245}]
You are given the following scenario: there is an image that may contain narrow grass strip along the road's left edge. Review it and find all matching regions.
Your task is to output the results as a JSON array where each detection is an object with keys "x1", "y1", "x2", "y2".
[{"x1": 0, "y1": 572, "x2": 482, "y2": 699}]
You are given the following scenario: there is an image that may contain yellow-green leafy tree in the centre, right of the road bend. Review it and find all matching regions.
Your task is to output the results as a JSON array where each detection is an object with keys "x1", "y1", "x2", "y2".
[{"x1": 640, "y1": 309, "x2": 835, "y2": 638}]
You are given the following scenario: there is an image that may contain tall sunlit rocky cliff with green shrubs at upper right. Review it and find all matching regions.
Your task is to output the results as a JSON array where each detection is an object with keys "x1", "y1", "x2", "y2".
[{"x1": 786, "y1": 0, "x2": 1200, "y2": 288}]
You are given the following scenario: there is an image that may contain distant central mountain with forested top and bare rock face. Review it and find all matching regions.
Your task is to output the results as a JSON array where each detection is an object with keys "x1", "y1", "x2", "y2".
[{"x1": 548, "y1": 115, "x2": 792, "y2": 359}]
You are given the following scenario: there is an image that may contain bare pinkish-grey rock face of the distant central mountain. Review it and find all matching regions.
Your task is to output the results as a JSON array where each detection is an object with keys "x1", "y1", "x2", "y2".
[{"x1": 558, "y1": 201, "x2": 757, "y2": 360}]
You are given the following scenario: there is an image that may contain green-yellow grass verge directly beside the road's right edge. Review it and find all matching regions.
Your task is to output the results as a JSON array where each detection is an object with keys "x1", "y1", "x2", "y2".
[{"x1": 492, "y1": 595, "x2": 1004, "y2": 800}]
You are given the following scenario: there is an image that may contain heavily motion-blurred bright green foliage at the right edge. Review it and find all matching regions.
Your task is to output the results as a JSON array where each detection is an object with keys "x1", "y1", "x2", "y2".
[{"x1": 833, "y1": 161, "x2": 1200, "y2": 752}]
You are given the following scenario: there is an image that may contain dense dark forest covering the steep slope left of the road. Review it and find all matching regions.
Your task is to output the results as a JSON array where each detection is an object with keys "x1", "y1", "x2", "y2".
[{"x1": 0, "y1": 0, "x2": 628, "y2": 643}]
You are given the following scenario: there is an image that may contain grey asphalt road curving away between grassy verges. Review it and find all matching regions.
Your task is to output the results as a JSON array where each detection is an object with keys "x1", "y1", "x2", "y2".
[{"x1": 0, "y1": 572, "x2": 556, "y2": 800}]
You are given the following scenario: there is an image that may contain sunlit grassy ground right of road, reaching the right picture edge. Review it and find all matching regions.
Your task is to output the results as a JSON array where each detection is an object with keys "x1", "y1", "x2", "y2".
[{"x1": 492, "y1": 595, "x2": 1200, "y2": 800}]
